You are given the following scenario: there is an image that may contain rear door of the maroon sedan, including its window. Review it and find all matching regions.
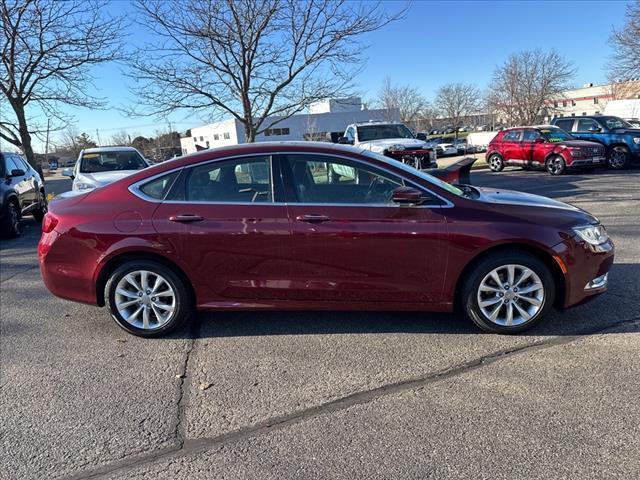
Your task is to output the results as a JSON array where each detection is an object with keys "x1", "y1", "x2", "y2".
[{"x1": 153, "y1": 155, "x2": 290, "y2": 305}]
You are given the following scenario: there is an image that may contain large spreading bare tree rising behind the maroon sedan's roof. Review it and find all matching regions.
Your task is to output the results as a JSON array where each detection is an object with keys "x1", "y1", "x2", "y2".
[{"x1": 127, "y1": 0, "x2": 398, "y2": 142}]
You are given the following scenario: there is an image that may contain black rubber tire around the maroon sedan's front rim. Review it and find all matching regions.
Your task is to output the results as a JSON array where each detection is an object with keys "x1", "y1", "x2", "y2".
[{"x1": 460, "y1": 250, "x2": 555, "y2": 334}]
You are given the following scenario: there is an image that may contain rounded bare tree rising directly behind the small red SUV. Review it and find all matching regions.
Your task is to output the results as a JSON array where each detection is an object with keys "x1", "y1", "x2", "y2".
[{"x1": 489, "y1": 50, "x2": 575, "y2": 125}]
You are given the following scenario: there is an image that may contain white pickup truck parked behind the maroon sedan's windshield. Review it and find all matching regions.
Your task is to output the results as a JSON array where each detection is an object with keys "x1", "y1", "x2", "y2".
[{"x1": 338, "y1": 122, "x2": 438, "y2": 170}]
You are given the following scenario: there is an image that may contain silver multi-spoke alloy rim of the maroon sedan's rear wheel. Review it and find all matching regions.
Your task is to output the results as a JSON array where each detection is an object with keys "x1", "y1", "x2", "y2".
[{"x1": 115, "y1": 270, "x2": 176, "y2": 330}]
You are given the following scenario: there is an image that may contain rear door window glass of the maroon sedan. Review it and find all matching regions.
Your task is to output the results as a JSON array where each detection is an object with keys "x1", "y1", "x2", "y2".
[{"x1": 185, "y1": 156, "x2": 273, "y2": 203}]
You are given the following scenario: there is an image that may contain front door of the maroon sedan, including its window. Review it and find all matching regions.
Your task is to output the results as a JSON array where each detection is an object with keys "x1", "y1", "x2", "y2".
[{"x1": 280, "y1": 153, "x2": 447, "y2": 303}]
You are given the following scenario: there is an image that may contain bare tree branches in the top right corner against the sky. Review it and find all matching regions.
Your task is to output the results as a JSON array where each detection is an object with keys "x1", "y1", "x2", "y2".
[{"x1": 609, "y1": 0, "x2": 640, "y2": 81}]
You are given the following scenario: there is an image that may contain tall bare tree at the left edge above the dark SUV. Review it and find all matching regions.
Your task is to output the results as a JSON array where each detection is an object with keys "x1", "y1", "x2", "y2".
[{"x1": 0, "y1": 0, "x2": 122, "y2": 168}]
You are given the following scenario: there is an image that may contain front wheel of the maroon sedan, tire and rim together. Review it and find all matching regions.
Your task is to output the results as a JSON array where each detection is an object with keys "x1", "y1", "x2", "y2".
[{"x1": 462, "y1": 251, "x2": 555, "y2": 334}]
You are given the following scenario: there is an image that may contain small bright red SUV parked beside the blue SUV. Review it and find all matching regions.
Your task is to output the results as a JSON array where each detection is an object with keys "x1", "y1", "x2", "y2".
[{"x1": 486, "y1": 125, "x2": 606, "y2": 175}]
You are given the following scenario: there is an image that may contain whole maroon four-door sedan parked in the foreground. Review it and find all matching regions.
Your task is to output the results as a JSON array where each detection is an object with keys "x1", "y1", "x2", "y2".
[{"x1": 39, "y1": 142, "x2": 613, "y2": 336}]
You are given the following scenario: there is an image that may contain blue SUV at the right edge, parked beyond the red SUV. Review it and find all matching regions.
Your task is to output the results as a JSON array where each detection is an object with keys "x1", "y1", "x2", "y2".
[{"x1": 551, "y1": 115, "x2": 640, "y2": 170}]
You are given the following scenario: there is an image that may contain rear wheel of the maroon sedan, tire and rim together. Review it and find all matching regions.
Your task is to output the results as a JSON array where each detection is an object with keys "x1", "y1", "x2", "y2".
[{"x1": 105, "y1": 260, "x2": 194, "y2": 337}]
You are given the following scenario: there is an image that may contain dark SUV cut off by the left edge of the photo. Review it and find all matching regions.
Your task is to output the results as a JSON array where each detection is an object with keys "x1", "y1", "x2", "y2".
[{"x1": 0, "y1": 152, "x2": 47, "y2": 237}]
